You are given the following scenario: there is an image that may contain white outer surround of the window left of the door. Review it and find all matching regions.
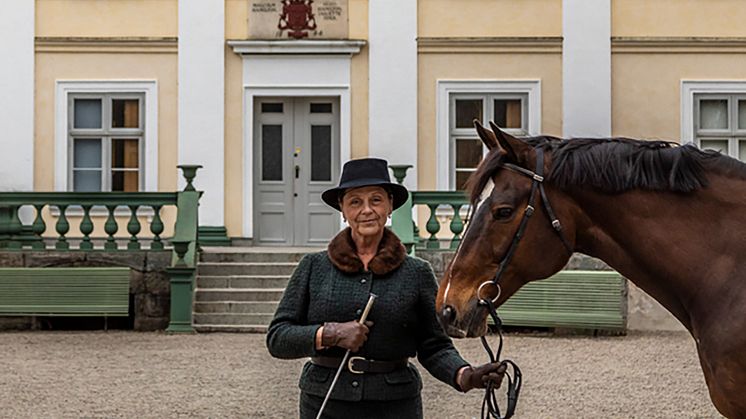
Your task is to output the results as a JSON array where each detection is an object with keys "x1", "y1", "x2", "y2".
[{"x1": 54, "y1": 80, "x2": 158, "y2": 192}]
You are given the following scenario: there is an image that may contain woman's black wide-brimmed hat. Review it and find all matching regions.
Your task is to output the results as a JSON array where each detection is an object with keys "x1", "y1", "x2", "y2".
[{"x1": 321, "y1": 158, "x2": 409, "y2": 211}]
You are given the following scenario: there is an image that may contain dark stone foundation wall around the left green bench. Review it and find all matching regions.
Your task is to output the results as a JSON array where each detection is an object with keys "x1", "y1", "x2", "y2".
[{"x1": 0, "y1": 250, "x2": 171, "y2": 331}]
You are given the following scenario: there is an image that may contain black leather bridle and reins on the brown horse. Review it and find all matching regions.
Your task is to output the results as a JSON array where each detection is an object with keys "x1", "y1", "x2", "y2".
[{"x1": 468, "y1": 148, "x2": 573, "y2": 419}]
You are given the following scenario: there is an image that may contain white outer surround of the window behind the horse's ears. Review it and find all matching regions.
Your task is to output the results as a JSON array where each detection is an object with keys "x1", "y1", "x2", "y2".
[{"x1": 435, "y1": 80, "x2": 541, "y2": 191}]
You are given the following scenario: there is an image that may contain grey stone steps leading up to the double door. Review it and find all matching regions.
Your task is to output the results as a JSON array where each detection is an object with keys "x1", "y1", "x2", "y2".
[{"x1": 192, "y1": 247, "x2": 320, "y2": 333}]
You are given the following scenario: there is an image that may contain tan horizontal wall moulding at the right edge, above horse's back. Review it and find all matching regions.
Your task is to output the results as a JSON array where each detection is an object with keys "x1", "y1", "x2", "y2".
[{"x1": 611, "y1": 37, "x2": 746, "y2": 54}]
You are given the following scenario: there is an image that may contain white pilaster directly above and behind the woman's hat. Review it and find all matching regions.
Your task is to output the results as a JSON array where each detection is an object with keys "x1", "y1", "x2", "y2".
[{"x1": 368, "y1": 0, "x2": 417, "y2": 189}]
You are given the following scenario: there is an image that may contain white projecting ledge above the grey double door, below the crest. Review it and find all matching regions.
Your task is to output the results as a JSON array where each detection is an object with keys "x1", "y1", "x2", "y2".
[{"x1": 228, "y1": 39, "x2": 366, "y2": 55}]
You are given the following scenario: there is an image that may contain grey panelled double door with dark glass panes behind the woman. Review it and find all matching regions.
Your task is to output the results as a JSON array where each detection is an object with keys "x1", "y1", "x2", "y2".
[{"x1": 254, "y1": 98, "x2": 340, "y2": 246}]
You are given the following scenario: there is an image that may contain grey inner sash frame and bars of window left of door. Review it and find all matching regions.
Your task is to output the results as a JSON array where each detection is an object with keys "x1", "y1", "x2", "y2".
[{"x1": 67, "y1": 93, "x2": 146, "y2": 192}]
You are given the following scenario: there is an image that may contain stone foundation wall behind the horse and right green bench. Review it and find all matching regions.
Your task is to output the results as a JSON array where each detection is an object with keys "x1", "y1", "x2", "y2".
[{"x1": 417, "y1": 250, "x2": 685, "y2": 331}]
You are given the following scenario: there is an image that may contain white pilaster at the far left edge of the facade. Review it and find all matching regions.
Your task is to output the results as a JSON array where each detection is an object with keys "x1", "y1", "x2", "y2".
[{"x1": 0, "y1": 1, "x2": 34, "y2": 191}]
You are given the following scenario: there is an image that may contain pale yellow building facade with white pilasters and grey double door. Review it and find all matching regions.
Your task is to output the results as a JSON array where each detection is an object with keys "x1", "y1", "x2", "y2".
[{"x1": 0, "y1": 0, "x2": 746, "y2": 245}]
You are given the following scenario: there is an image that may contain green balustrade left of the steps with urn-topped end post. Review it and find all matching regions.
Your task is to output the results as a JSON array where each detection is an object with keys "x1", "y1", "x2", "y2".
[{"x1": 0, "y1": 165, "x2": 202, "y2": 332}]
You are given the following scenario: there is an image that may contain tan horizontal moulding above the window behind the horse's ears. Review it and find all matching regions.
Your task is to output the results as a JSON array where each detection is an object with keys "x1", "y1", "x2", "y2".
[{"x1": 417, "y1": 36, "x2": 562, "y2": 54}]
